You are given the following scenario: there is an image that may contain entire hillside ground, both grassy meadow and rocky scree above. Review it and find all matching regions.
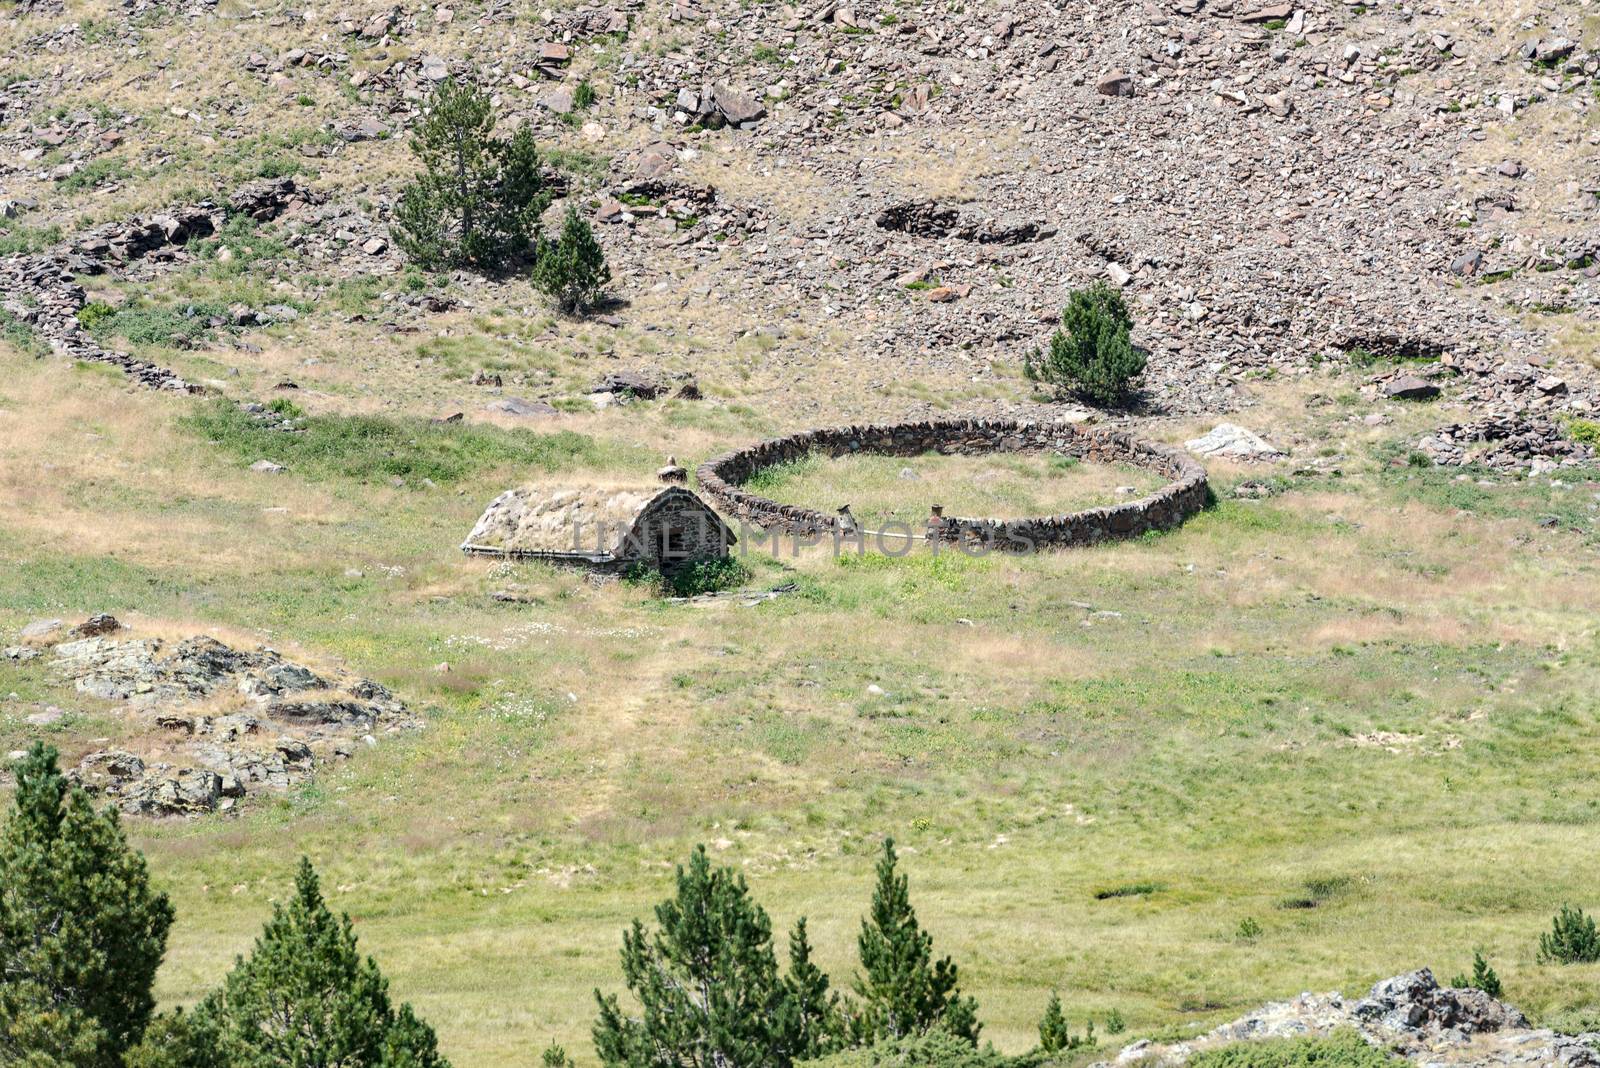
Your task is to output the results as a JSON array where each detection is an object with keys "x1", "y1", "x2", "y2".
[{"x1": 0, "y1": 0, "x2": 1600, "y2": 1068}]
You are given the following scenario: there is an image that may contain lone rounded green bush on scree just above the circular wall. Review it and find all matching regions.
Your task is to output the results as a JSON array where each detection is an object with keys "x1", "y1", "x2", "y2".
[{"x1": 1022, "y1": 283, "x2": 1146, "y2": 404}]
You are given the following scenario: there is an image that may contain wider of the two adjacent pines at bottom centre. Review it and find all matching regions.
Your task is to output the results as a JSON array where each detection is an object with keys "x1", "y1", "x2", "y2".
[{"x1": 594, "y1": 846, "x2": 795, "y2": 1068}]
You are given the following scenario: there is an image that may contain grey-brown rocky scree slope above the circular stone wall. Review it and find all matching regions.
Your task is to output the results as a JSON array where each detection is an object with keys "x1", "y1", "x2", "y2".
[{"x1": 0, "y1": 0, "x2": 1600, "y2": 454}]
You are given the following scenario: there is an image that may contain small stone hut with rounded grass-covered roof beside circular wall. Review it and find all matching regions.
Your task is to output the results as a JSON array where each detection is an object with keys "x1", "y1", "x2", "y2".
[{"x1": 461, "y1": 476, "x2": 738, "y2": 571}]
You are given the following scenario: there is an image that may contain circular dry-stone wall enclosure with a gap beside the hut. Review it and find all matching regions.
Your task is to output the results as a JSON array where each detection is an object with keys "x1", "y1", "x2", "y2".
[{"x1": 696, "y1": 419, "x2": 1206, "y2": 550}]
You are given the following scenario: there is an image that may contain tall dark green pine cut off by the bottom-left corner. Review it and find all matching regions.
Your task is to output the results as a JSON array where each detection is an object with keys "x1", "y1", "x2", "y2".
[{"x1": 0, "y1": 743, "x2": 173, "y2": 1068}]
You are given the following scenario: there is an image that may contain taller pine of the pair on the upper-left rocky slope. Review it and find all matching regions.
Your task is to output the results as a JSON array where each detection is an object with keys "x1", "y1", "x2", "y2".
[{"x1": 390, "y1": 78, "x2": 550, "y2": 270}]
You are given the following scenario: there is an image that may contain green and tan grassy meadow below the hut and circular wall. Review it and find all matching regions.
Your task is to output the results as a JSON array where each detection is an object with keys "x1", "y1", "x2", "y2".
[{"x1": 0, "y1": 361, "x2": 1600, "y2": 1065}]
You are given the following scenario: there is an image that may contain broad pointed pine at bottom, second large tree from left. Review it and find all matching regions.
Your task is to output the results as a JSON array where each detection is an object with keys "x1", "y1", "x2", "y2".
[{"x1": 192, "y1": 859, "x2": 450, "y2": 1068}]
